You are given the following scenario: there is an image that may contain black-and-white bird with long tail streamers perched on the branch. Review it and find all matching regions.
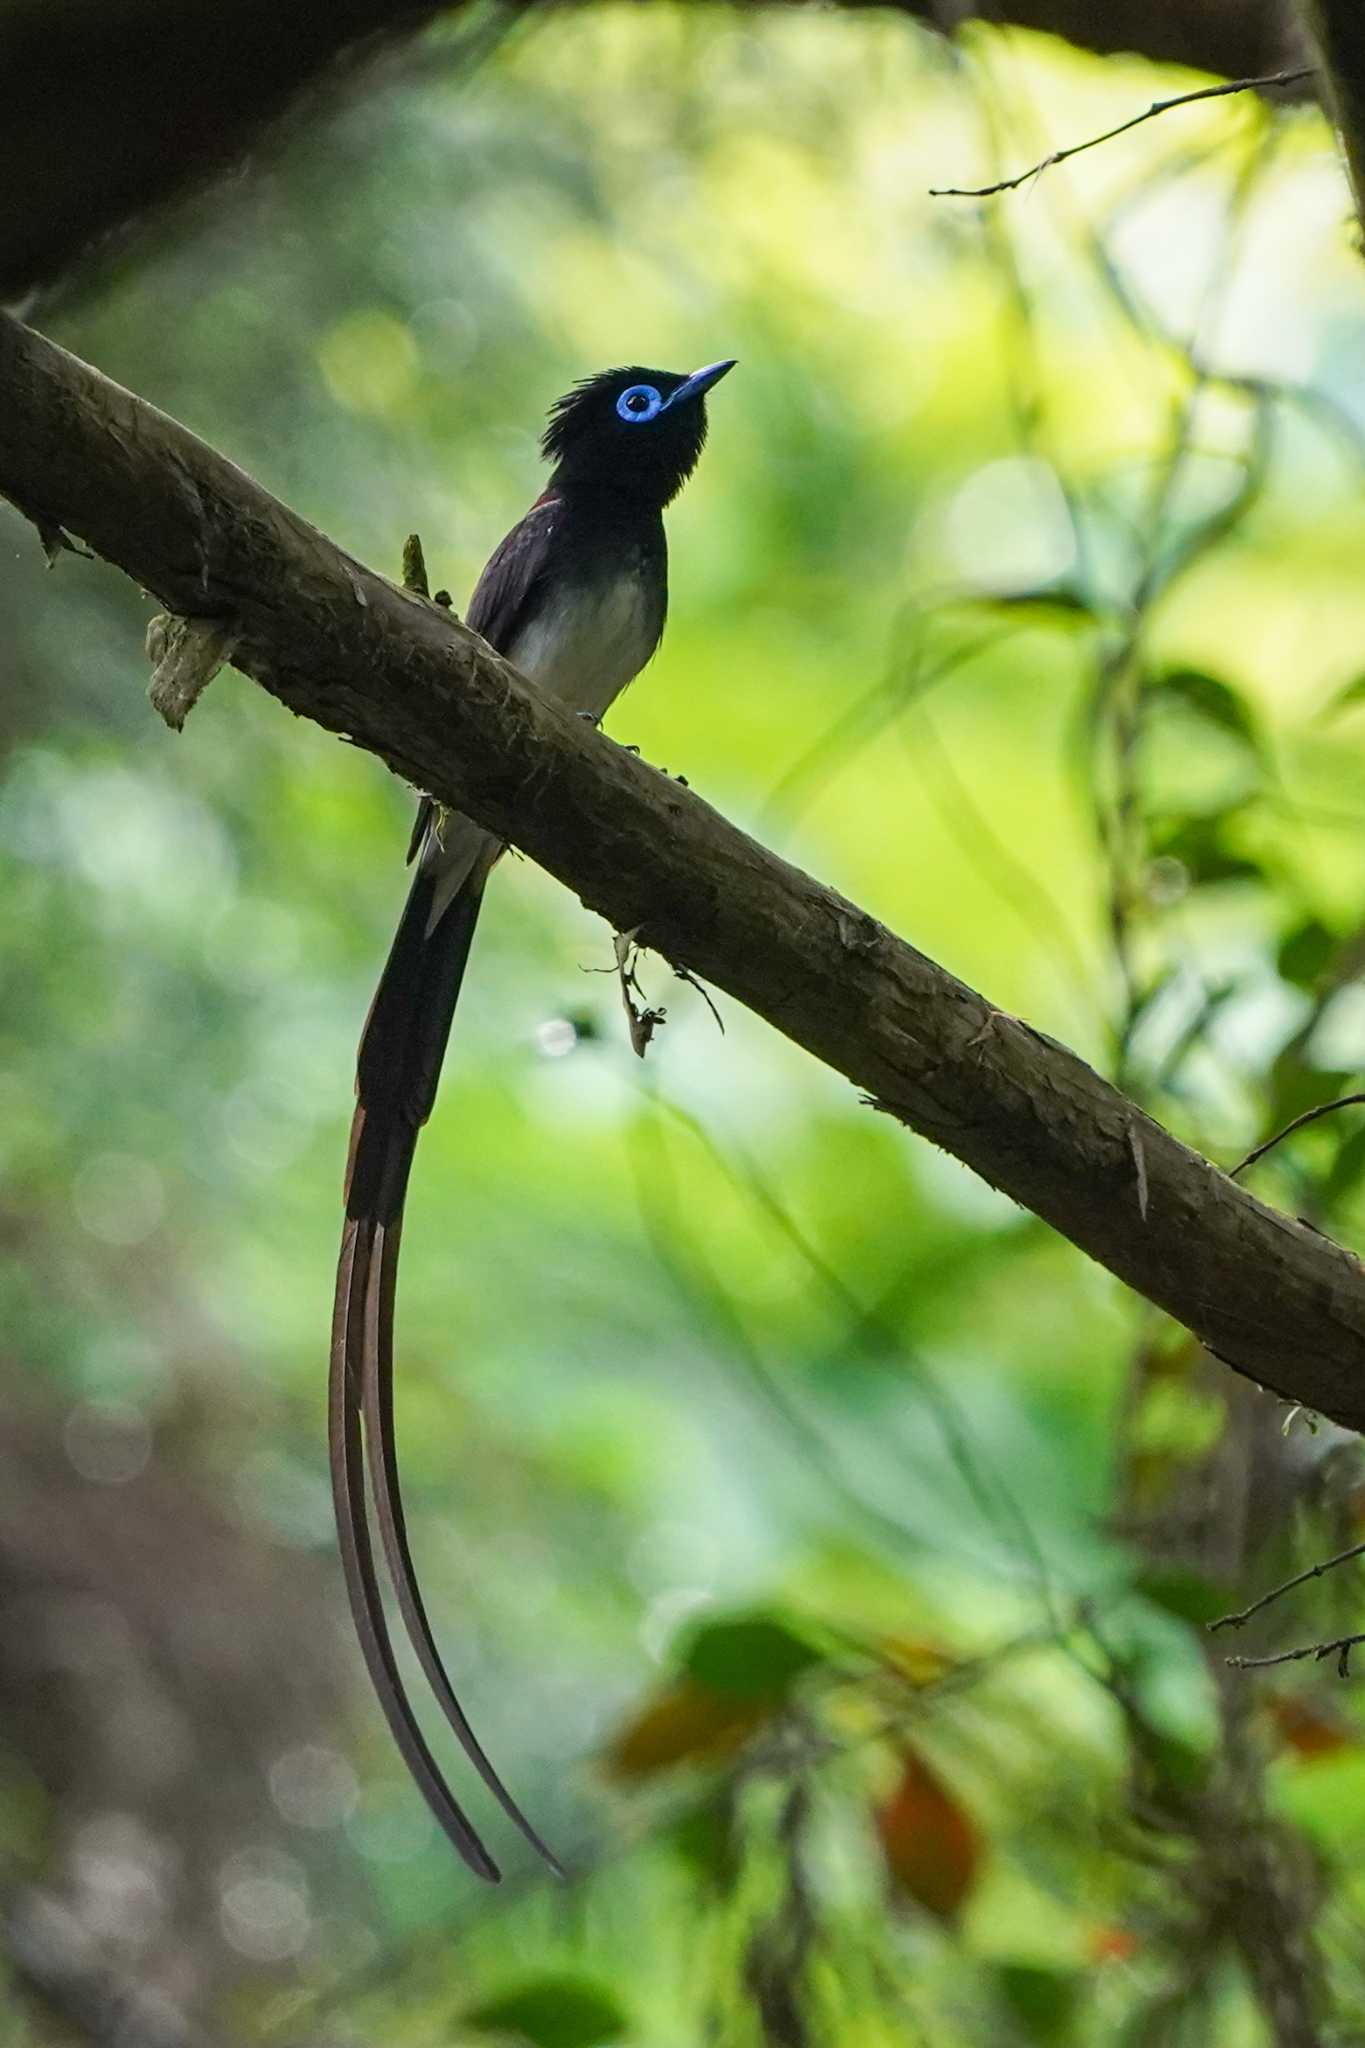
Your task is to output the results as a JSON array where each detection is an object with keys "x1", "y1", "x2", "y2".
[{"x1": 327, "y1": 358, "x2": 735, "y2": 1884}]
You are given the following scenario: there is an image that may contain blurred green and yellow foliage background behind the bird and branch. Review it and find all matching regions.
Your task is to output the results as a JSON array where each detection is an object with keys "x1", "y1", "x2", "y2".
[{"x1": 0, "y1": 6, "x2": 1365, "y2": 2048}]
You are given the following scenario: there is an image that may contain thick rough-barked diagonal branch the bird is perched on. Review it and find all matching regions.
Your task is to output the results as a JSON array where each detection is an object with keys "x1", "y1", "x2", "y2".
[{"x1": 0, "y1": 315, "x2": 1365, "y2": 1427}]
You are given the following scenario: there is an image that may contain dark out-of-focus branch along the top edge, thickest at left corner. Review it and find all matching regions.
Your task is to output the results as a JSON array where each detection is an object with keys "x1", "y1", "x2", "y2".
[{"x1": 0, "y1": 0, "x2": 1309, "y2": 295}]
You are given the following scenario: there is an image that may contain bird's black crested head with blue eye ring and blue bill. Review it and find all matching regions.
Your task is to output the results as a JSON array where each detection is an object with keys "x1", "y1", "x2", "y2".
[{"x1": 540, "y1": 360, "x2": 735, "y2": 506}]
